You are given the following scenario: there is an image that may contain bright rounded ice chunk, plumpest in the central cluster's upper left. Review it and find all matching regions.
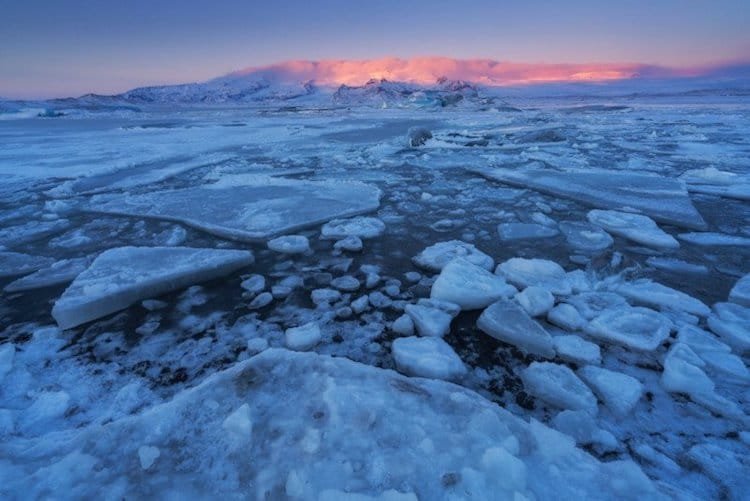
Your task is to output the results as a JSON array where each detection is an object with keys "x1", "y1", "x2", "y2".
[{"x1": 430, "y1": 258, "x2": 516, "y2": 310}]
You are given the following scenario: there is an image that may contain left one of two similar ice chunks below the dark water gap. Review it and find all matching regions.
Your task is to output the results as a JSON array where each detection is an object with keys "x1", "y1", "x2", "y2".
[{"x1": 521, "y1": 362, "x2": 599, "y2": 415}]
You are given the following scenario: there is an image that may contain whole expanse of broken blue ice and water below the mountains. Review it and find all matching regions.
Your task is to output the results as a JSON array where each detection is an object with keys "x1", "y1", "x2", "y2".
[{"x1": 0, "y1": 93, "x2": 750, "y2": 500}]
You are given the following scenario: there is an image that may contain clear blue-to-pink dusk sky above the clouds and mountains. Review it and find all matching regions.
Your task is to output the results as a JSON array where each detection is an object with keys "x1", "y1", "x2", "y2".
[{"x1": 0, "y1": 0, "x2": 750, "y2": 98}]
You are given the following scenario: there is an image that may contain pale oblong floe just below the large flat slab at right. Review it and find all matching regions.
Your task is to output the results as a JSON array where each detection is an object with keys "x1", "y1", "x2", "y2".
[{"x1": 588, "y1": 209, "x2": 680, "y2": 249}]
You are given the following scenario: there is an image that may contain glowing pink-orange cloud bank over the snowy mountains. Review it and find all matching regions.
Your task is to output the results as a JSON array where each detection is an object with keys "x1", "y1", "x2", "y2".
[{"x1": 225, "y1": 57, "x2": 740, "y2": 86}]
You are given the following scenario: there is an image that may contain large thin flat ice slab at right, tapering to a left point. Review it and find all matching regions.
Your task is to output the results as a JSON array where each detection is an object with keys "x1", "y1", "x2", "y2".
[{"x1": 471, "y1": 168, "x2": 706, "y2": 230}]
